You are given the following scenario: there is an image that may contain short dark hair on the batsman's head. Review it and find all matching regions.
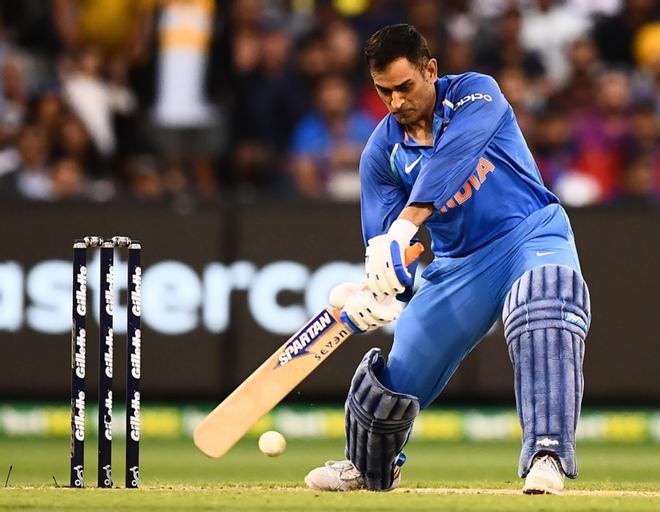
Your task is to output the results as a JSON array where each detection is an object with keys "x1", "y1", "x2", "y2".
[{"x1": 364, "y1": 23, "x2": 431, "y2": 71}]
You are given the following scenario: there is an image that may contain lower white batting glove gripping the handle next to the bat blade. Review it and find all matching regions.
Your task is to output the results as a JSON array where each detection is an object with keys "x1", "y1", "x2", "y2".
[{"x1": 330, "y1": 283, "x2": 403, "y2": 332}]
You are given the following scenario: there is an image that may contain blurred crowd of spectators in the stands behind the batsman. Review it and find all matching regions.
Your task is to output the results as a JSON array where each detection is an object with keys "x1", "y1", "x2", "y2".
[{"x1": 0, "y1": 0, "x2": 660, "y2": 206}]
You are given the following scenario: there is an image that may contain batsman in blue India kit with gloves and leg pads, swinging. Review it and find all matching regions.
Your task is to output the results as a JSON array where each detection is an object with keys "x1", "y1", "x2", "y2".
[{"x1": 305, "y1": 25, "x2": 591, "y2": 494}]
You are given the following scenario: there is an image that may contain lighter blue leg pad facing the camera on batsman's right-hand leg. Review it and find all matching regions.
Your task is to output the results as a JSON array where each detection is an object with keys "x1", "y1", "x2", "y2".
[{"x1": 502, "y1": 265, "x2": 591, "y2": 478}]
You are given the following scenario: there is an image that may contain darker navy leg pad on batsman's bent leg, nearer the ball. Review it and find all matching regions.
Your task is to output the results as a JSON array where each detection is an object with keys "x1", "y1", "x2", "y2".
[{"x1": 346, "y1": 348, "x2": 419, "y2": 490}]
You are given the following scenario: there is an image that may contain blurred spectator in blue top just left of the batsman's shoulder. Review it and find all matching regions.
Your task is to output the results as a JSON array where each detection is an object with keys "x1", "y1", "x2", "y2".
[{"x1": 291, "y1": 75, "x2": 375, "y2": 200}]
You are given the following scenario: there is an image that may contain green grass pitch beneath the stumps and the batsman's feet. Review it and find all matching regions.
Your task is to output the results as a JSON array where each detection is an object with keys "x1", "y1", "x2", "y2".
[{"x1": 0, "y1": 438, "x2": 660, "y2": 512}]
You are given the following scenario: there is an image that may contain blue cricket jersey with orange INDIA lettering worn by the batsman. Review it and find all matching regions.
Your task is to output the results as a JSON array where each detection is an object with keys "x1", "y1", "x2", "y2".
[{"x1": 360, "y1": 73, "x2": 570, "y2": 258}]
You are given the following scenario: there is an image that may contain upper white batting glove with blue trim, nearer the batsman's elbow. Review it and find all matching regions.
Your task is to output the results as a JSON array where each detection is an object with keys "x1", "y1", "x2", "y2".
[{"x1": 365, "y1": 219, "x2": 417, "y2": 301}]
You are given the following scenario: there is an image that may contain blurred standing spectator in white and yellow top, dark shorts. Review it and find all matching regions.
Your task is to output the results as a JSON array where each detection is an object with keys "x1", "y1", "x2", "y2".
[{"x1": 153, "y1": 0, "x2": 226, "y2": 197}]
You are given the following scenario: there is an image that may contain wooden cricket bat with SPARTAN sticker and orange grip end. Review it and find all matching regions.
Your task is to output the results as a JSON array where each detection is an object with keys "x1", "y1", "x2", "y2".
[{"x1": 193, "y1": 242, "x2": 424, "y2": 458}]
